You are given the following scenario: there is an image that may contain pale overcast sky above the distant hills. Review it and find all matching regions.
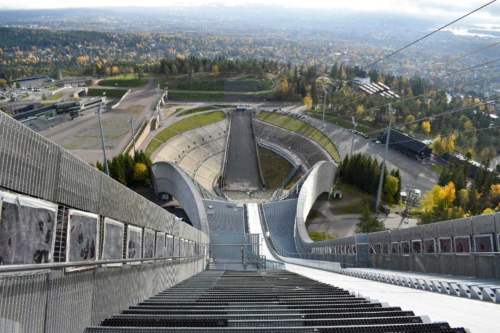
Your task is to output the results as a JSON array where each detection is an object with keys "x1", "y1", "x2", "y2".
[{"x1": 0, "y1": 0, "x2": 500, "y2": 25}]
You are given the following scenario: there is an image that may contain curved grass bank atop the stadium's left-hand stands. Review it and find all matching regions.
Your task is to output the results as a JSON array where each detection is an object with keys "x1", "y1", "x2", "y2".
[{"x1": 146, "y1": 111, "x2": 225, "y2": 156}]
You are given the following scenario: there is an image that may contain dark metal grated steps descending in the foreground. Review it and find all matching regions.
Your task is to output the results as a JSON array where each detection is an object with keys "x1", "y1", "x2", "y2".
[{"x1": 85, "y1": 271, "x2": 465, "y2": 333}]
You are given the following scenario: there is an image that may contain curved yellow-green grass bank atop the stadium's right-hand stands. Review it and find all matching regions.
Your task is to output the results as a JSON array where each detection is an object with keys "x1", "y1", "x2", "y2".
[{"x1": 258, "y1": 112, "x2": 340, "y2": 162}]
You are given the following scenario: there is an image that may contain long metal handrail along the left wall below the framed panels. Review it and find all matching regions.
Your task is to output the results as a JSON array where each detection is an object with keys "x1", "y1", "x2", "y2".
[{"x1": 0, "y1": 255, "x2": 204, "y2": 274}]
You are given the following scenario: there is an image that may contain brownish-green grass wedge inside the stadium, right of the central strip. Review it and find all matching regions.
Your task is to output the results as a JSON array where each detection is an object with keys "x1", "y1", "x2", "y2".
[{"x1": 259, "y1": 147, "x2": 293, "y2": 189}]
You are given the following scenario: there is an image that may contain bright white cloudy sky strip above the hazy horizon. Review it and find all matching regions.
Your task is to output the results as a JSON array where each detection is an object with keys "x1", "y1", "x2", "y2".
[{"x1": 0, "y1": 0, "x2": 500, "y2": 23}]
